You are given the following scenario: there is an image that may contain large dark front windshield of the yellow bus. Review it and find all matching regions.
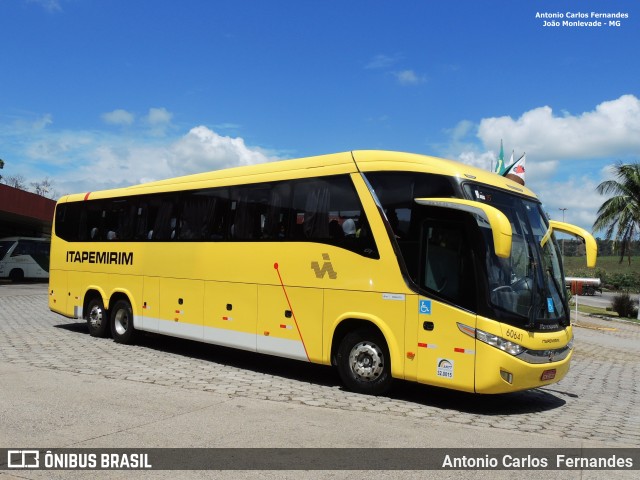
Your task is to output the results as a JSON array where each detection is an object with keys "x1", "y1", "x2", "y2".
[{"x1": 465, "y1": 184, "x2": 567, "y2": 330}]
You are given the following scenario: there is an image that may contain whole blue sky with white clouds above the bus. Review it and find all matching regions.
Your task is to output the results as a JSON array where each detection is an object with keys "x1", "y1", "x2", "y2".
[{"x1": 0, "y1": 0, "x2": 640, "y2": 230}]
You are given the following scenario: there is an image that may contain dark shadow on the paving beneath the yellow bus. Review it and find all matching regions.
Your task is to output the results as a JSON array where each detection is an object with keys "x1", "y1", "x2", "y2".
[{"x1": 56, "y1": 322, "x2": 571, "y2": 416}]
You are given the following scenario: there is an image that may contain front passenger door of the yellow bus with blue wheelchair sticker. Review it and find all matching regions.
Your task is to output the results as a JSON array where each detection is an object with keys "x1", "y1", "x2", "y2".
[{"x1": 416, "y1": 219, "x2": 477, "y2": 392}]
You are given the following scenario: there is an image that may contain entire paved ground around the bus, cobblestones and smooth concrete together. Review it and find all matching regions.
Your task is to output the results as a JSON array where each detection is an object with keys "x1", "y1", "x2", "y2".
[{"x1": 0, "y1": 284, "x2": 640, "y2": 479}]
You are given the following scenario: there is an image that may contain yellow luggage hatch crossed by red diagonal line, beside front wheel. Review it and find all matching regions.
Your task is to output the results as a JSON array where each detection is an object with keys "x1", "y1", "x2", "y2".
[{"x1": 257, "y1": 285, "x2": 323, "y2": 362}]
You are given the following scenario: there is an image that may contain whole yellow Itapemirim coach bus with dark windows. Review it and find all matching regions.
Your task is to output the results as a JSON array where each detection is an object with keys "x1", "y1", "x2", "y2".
[{"x1": 49, "y1": 151, "x2": 596, "y2": 394}]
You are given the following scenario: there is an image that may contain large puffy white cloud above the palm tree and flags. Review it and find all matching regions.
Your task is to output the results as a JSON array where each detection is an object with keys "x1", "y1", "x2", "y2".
[{"x1": 478, "y1": 95, "x2": 640, "y2": 160}]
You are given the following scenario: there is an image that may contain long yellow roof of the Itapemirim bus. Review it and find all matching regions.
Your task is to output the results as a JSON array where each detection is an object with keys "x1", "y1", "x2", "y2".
[{"x1": 59, "y1": 150, "x2": 535, "y2": 202}]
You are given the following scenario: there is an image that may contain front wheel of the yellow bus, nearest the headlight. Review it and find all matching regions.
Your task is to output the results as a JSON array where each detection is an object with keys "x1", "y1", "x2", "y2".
[{"x1": 336, "y1": 328, "x2": 393, "y2": 395}]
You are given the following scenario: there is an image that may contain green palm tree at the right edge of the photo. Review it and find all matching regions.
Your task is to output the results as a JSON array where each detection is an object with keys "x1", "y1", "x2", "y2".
[{"x1": 593, "y1": 163, "x2": 640, "y2": 263}]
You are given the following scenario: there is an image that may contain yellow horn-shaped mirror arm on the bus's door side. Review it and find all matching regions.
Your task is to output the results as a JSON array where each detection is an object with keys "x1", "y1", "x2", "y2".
[{"x1": 415, "y1": 198, "x2": 512, "y2": 258}]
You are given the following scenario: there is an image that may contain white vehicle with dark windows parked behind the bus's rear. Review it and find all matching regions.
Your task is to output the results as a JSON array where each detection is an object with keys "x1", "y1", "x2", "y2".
[{"x1": 0, "y1": 237, "x2": 51, "y2": 282}]
